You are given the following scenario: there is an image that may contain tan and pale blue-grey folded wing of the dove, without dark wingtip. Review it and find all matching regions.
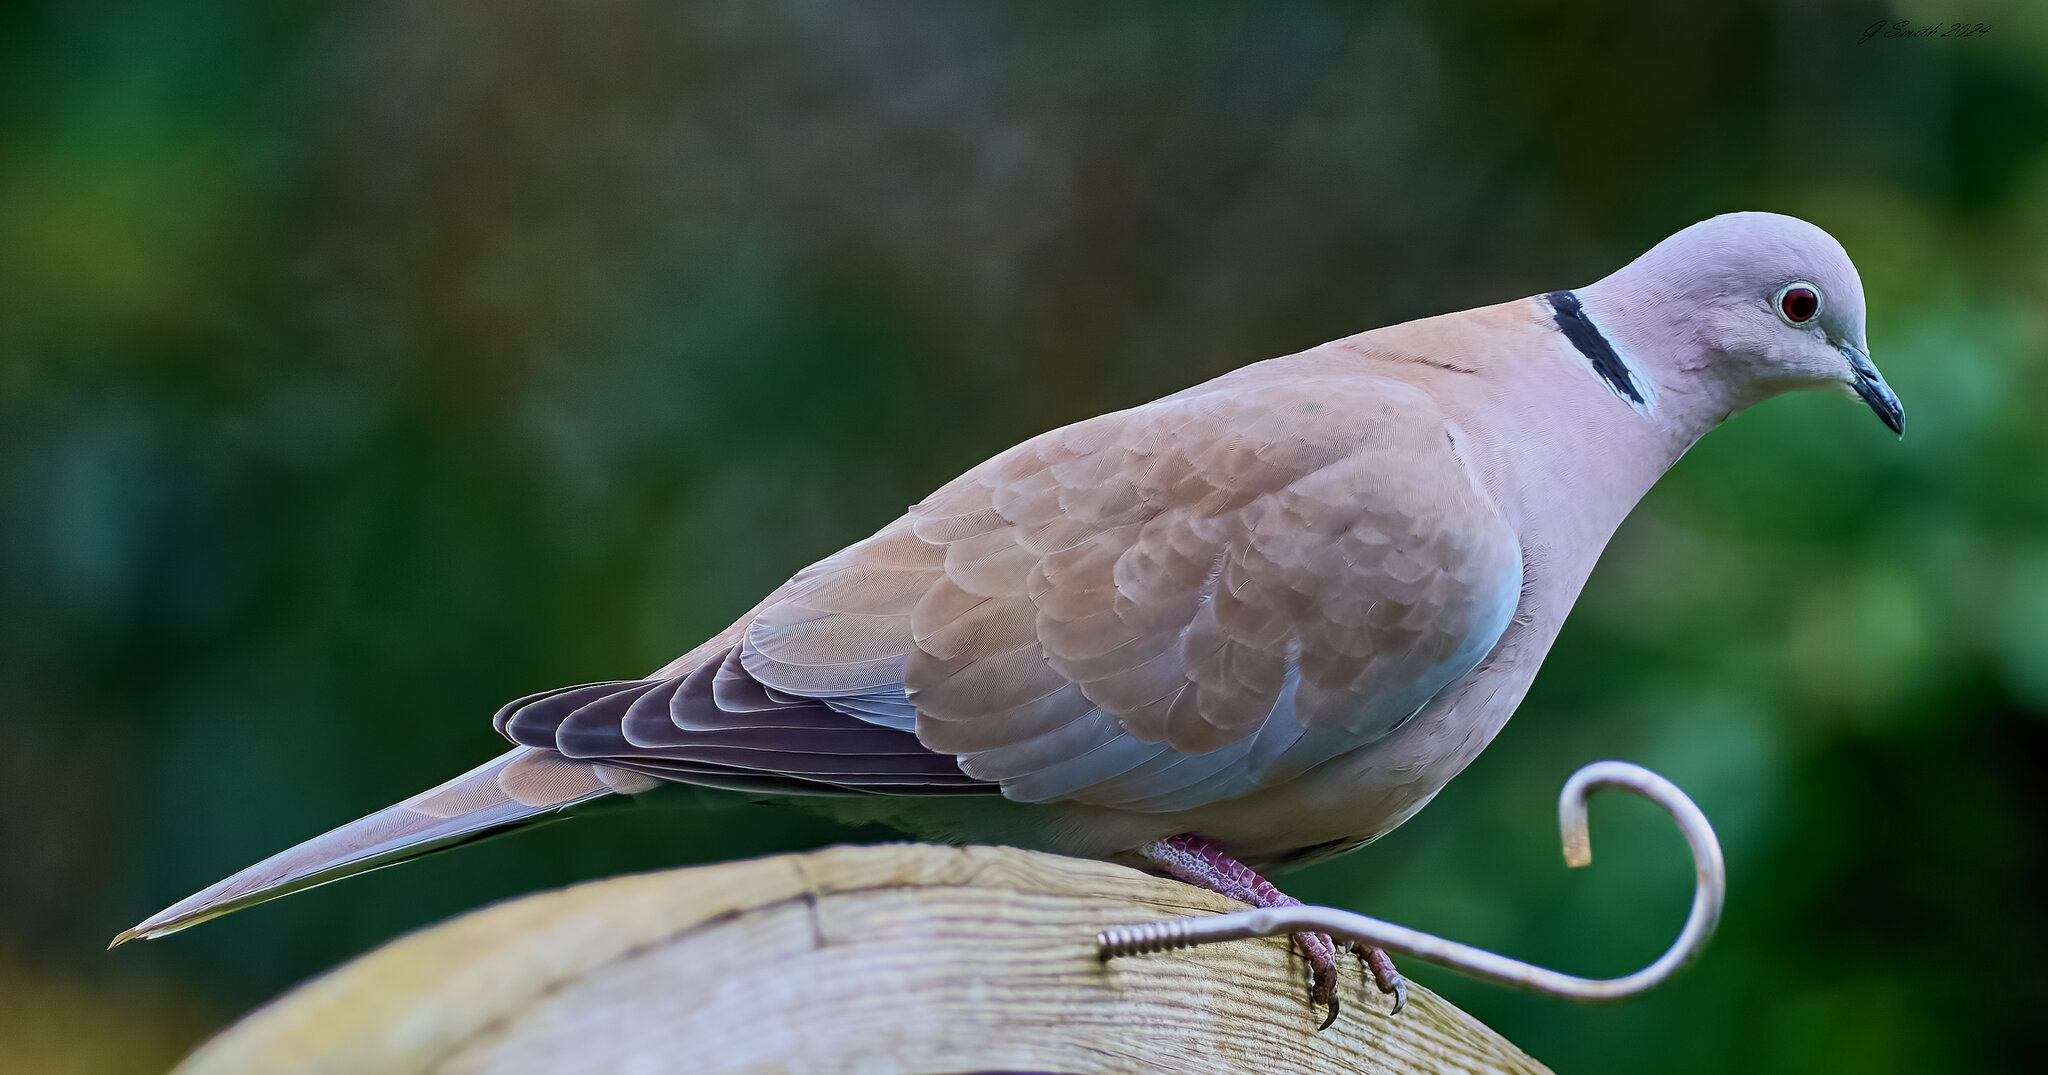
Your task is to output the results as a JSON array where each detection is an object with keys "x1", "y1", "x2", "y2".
[{"x1": 739, "y1": 360, "x2": 1522, "y2": 811}]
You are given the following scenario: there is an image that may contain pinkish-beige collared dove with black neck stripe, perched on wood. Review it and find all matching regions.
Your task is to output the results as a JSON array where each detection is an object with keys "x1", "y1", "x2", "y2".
[{"x1": 117, "y1": 213, "x2": 1905, "y2": 1018}]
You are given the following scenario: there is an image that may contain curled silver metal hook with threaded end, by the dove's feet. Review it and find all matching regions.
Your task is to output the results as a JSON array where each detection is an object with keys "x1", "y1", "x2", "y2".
[{"x1": 1096, "y1": 762, "x2": 1729, "y2": 1001}]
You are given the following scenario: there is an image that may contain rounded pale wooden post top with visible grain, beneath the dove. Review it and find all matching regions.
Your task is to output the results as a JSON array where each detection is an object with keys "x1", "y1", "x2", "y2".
[{"x1": 178, "y1": 844, "x2": 1546, "y2": 1075}]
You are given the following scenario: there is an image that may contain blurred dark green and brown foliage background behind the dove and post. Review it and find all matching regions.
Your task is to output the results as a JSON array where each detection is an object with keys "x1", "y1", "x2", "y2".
[{"x1": 0, "y1": 0, "x2": 2048, "y2": 1073}]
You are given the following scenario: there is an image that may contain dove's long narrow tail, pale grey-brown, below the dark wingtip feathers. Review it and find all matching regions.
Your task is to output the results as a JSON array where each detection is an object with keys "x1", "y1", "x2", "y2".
[{"x1": 115, "y1": 747, "x2": 655, "y2": 944}]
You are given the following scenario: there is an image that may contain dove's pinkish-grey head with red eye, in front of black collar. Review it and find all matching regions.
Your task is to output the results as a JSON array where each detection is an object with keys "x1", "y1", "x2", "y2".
[{"x1": 1581, "y1": 213, "x2": 1905, "y2": 432}]
